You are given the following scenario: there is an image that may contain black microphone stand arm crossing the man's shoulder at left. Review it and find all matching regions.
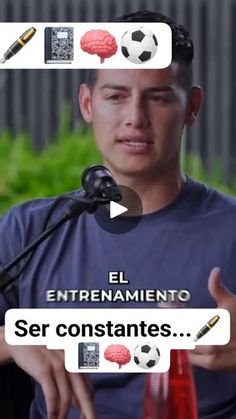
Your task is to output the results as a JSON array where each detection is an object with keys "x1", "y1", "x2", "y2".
[{"x1": 0, "y1": 198, "x2": 110, "y2": 293}]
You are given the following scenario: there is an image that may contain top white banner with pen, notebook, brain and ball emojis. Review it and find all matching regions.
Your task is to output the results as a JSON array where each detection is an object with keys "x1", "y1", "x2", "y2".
[{"x1": 0, "y1": 22, "x2": 172, "y2": 69}]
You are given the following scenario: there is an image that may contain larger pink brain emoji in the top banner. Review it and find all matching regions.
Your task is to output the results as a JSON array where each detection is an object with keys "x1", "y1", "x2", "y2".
[{"x1": 80, "y1": 29, "x2": 118, "y2": 63}]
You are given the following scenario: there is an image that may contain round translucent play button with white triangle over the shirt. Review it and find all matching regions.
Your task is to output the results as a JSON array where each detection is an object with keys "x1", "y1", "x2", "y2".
[{"x1": 94, "y1": 185, "x2": 143, "y2": 234}]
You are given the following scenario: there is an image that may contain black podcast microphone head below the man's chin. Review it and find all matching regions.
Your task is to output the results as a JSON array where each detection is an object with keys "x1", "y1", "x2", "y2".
[{"x1": 81, "y1": 165, "x2": 122, "y2": 201}]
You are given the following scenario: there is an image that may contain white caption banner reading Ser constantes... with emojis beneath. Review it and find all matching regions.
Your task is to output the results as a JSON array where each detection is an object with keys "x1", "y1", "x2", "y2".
[{"x1": 5, "y1": 308, "x2": 230, "y2": 372}]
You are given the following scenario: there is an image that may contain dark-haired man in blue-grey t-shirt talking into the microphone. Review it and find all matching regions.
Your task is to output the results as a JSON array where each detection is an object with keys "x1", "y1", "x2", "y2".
[{"x1": 0, "y1": 12, "x2": 236, "y2": 419}]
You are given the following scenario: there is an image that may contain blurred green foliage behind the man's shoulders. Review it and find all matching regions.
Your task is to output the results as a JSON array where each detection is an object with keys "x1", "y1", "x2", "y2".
[{"x1": 0, "y1": 128, "x2": 236, "y2": 214}]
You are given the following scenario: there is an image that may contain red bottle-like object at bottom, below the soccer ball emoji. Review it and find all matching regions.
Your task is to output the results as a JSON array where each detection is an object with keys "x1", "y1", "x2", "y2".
[{"x1": 143, "y1": 349, "x2": 198, "y2": 419}]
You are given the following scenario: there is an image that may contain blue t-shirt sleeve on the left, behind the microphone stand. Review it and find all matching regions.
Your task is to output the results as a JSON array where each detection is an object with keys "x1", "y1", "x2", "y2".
[{"x1": 0, "y1": 198, "x2": 67, "y2": 324}]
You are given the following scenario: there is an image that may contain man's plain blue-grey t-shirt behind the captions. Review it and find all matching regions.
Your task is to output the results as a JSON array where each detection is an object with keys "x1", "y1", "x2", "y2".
[{"x1": 0, "y1": 177, "x2": 236, "y2": 419}]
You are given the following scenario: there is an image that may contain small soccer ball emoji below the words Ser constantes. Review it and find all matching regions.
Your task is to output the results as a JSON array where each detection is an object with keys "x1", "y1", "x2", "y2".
[{"x1": 134, "y1": 343, "x2": 160, "y2": 369}]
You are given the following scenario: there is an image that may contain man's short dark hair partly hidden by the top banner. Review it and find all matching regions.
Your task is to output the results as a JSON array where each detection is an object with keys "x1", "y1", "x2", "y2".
[{"x1": 87, "y1": 10, "x2": 193, "y2": 89}]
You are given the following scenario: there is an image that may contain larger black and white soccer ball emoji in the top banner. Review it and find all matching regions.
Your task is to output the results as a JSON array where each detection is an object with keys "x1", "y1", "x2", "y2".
[{"x1": 121, "y1": 27, "x2": 158, "y2": 64}]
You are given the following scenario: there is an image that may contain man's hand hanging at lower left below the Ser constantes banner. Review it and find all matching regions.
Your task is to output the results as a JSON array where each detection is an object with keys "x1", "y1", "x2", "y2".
[{"x1": 9, "y1": 345, "x2": 96, "y2": 419}]
